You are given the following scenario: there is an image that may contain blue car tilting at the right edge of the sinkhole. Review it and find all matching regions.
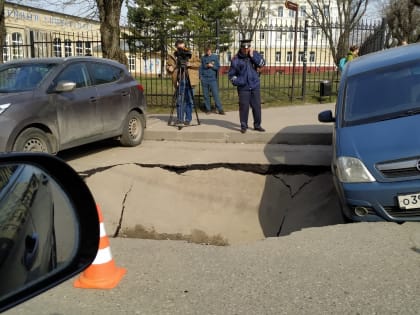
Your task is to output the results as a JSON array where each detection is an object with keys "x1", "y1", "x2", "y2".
[{"x1": 318, "y1": 44, "x2": 420, "y2": 222}]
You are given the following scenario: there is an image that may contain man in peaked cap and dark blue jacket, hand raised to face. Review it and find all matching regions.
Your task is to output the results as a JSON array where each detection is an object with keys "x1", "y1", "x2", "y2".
[{"x1": 228, "y1": 40, "x2": 265, "y2": 133}]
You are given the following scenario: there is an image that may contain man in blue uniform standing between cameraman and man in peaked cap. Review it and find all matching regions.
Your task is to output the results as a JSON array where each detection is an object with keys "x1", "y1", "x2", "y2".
[{"x1": 199, "y1": 47, "x2": 225, "y2": 115}]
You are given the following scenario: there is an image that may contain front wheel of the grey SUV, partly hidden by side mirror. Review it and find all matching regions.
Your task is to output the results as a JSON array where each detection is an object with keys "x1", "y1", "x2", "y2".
[{"x1": 13, "y1": 128, "x2": 52, "y2": 153}]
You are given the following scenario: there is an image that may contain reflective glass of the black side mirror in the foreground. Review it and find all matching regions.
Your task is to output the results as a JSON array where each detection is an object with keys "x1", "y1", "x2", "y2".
[{"x1": 0, "y1": 164, "x2": 57, "y2": 295}]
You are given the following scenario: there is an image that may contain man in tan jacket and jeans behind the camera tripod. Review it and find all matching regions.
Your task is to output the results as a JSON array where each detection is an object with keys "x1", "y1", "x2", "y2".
[{"x1": 166, "y1": 39, "x2": 200, "y2": 125}]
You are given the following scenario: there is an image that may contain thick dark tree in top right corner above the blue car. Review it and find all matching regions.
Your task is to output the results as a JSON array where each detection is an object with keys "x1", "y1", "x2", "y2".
[{"x1": 384, "y1": 0, "x2": 420, "y2": 45}]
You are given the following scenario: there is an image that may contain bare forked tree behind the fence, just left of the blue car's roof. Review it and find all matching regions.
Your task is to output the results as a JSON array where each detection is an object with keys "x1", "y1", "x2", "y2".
[{"x1": 307, "y1": 0, "x2": 369, "y2": 64}]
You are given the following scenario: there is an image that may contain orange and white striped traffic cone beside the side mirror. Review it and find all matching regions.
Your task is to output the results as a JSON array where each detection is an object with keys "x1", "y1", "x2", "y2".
[{"x1": 73, "y1": 205, "x2": 127, "y2": 289}]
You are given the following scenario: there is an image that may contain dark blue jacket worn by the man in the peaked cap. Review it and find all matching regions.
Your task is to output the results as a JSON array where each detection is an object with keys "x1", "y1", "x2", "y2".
[{"x1": 228, "y1": 51, "x2": 265, "y2": 90}]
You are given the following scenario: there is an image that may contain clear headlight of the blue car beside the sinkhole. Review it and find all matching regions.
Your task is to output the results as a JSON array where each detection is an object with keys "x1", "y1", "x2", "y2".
[{"x1": 337, "y1": 156, "x2": 376, "y2": 183}]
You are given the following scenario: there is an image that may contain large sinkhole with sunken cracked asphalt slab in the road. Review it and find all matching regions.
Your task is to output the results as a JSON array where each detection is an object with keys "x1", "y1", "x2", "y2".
[{"x1": 84, "y1": 163, "x2": 344, "y2": 246}]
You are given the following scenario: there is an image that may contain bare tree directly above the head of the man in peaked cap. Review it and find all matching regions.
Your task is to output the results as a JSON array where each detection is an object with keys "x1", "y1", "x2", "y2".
[{"x1": 233, "y1": 0, "x2": 267, "y2": 38}]
